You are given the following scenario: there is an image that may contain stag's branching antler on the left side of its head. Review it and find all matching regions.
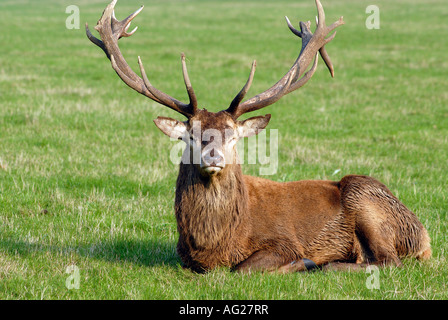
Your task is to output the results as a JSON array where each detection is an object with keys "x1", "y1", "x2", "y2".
[{"x1": 86, "y1": 0, "x2": 197, "y2": 117}]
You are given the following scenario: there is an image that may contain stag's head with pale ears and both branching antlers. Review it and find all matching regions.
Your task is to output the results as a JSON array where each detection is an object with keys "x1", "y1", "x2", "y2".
[{"x1": 86, "y1": 0, "x2": 344, "y2": 176}]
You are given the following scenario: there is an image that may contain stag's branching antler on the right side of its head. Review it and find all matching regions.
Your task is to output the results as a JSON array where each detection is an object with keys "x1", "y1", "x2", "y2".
[{"x1": 226, "y1": 0, "x2": 344, "y2": 119}]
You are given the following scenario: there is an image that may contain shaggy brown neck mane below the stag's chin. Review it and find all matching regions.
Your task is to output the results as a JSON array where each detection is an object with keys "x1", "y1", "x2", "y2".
[{"x1": 175, "y1": 164, "x2": 248, "y2": 249}]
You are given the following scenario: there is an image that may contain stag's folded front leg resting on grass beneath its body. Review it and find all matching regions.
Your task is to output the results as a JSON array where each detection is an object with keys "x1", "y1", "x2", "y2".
[{"x1": 234, "y1": 251, "x2": 312, "y2": 273}]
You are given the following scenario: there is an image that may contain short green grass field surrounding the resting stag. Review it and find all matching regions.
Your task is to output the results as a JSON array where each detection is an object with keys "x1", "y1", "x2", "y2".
[{"x1": 0, "y1": 0, "x2": 448, "y2": 299}]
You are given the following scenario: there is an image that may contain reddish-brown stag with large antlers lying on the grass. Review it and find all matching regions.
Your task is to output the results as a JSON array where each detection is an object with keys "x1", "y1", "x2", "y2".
[{"x1": 86, "y1": 0, "x2": 431, "y2": 272}]
